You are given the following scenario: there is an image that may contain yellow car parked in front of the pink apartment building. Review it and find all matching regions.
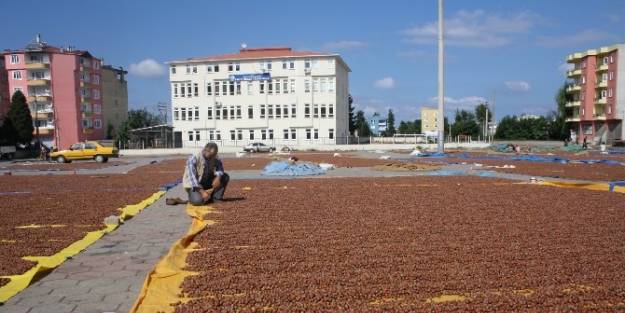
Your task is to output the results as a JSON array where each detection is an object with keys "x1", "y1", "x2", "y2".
[{"x1": 50, "y1": 141, "x2": 119, "y2": 163}]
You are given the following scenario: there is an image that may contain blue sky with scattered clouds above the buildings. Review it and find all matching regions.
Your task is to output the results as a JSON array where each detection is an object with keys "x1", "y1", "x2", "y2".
[{"x1": 0, "y1": 0, "x2": 625, "y2": 120}]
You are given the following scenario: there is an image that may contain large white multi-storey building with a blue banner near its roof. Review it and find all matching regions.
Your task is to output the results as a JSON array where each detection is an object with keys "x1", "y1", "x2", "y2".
[{"x1": 169, "y1": 47, "x2": 350, "y2": 147}]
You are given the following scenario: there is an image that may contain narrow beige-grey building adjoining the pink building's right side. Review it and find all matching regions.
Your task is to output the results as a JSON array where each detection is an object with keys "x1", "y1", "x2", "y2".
[{"x1": 101, "y1": 65, "x2": 128, "y2": 138}]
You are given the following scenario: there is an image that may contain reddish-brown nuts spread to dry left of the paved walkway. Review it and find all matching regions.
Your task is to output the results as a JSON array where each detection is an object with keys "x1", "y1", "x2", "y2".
[{"x1": 0, "y1": 161, "x2": 181, "y2": 276}]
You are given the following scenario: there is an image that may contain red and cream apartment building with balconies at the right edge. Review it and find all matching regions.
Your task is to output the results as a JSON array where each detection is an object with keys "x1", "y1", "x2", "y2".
[{"x1": 566, "y1": 44, "x2": 625, "y2": 143}]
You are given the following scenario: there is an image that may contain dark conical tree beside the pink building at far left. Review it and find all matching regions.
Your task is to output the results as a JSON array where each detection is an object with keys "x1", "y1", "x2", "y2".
[{"x1": 2, "y1": 90, "x2": 34, "y2": 144}]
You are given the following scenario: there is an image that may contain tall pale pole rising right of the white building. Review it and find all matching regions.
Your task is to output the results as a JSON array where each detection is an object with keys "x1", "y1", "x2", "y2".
[{"x1": 437, "y1": 0, "x2": 445, "y2": 153}]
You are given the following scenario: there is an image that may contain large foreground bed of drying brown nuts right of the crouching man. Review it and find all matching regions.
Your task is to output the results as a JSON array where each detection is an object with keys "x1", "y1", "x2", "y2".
[{"x1": 176, "y1": 177, "x2": 625, "y2": 313}]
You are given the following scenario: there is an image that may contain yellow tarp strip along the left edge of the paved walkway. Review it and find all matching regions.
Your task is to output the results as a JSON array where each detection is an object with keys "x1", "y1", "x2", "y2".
[{"x1": 0, "y1": 191, "x2": 165, "y2": 303}]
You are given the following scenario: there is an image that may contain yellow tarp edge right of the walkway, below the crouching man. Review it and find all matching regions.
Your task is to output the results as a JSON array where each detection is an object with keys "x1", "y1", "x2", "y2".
[{"x1": 130, "y1": 204, "x2": 214, "y2": 313}]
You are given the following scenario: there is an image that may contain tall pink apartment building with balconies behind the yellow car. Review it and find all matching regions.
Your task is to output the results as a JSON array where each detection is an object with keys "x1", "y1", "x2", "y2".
[{"x1": 0, "y1": 36, "x2": 105, "y2": 149}]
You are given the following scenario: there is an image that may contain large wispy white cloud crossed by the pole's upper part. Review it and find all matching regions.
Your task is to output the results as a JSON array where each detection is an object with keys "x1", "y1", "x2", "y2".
[{"x1": 402, "y1": 10, "x2": 539, "y2": 48}]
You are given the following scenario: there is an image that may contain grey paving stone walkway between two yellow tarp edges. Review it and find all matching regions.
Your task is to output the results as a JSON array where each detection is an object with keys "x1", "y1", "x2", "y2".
[{"x1": 0, "y1": 185, "x2": 191, "y2": 313}]
